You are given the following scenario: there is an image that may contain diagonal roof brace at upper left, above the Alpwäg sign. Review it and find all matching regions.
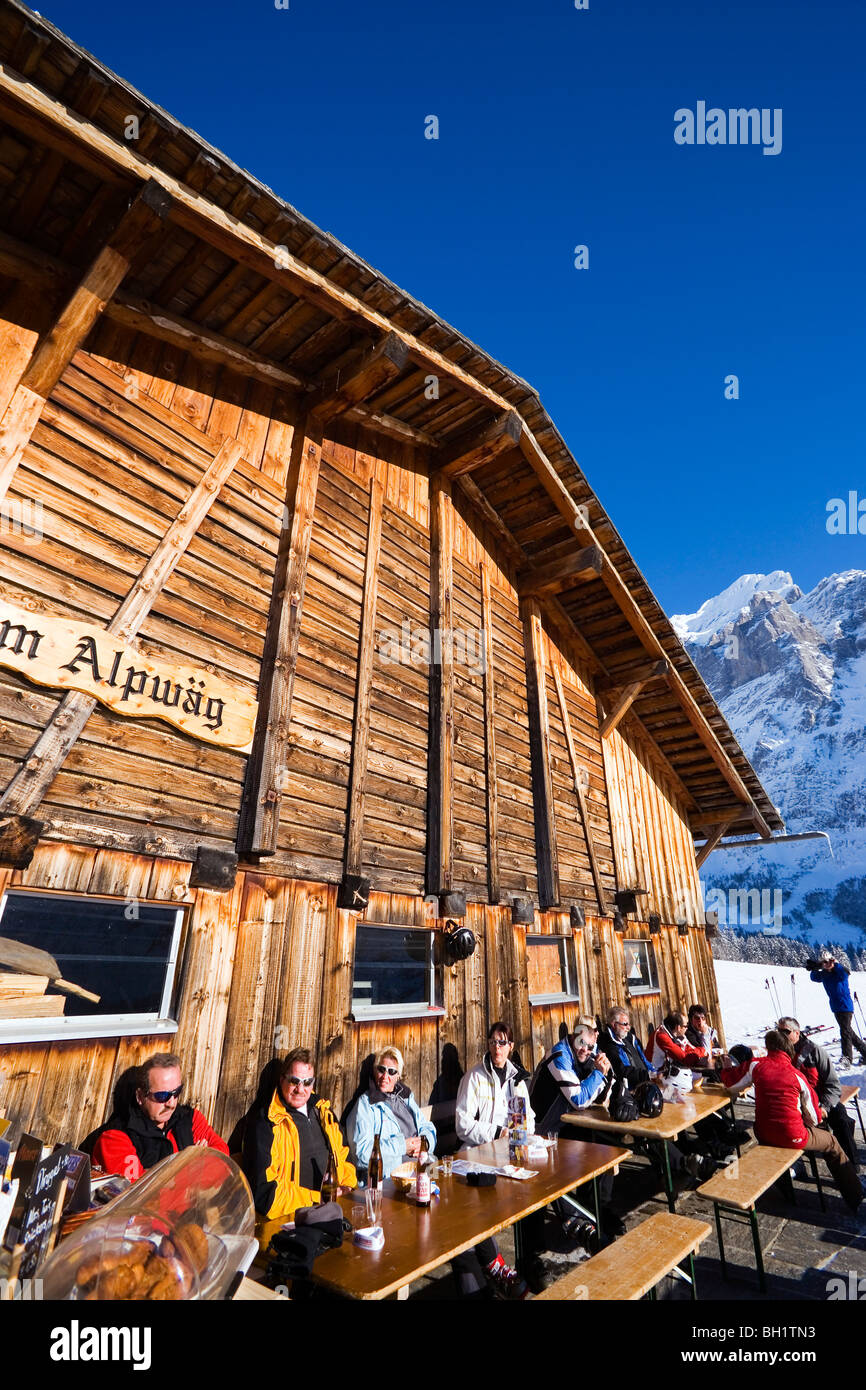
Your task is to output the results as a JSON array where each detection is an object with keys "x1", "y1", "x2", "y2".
[{"x1": 0, "y1": 182, "x2": 170, "y2": 502}]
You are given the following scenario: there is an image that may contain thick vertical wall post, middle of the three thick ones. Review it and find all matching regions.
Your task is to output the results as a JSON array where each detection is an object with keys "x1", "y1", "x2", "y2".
[{"x1": 427, "y1": 474, "x2": 455, "y2": 894}]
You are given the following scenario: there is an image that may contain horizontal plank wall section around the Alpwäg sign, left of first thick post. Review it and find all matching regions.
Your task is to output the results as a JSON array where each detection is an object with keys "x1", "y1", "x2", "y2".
[{"x1": 0, "y1": 333, "x2": 291, "y2": 848}]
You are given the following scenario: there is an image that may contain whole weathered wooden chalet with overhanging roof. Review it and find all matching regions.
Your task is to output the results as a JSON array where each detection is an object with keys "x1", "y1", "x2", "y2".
[{"x1": 0, "y1": 0, "x2": 783, "y2": 1140}]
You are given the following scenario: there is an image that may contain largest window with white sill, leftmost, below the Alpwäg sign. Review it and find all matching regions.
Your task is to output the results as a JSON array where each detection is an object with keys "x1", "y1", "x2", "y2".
[{"x1": 0, "y1": 891, "x2": 183, "y2": 1038}]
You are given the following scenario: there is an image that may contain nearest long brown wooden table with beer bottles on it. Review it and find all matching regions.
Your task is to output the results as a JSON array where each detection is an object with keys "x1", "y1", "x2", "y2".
[{"x1": 294, "y1": 1138, "x2": 626, "y2": 1300}]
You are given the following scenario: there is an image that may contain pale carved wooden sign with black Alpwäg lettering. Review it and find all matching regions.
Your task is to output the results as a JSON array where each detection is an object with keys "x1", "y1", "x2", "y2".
[{"x1": 0, "y1": 594, "x2": 257, "y2": 753}]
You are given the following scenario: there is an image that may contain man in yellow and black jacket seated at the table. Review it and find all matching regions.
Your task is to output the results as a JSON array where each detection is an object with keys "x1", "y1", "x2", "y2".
[{"x1": 242, "y1": 1047, "x2": 356, "y2": 1250}]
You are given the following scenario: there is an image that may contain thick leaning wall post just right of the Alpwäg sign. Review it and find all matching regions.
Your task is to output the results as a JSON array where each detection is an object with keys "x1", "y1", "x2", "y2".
[{"x1": 236, "y1": 420, "x2": 322, "y2": 855}]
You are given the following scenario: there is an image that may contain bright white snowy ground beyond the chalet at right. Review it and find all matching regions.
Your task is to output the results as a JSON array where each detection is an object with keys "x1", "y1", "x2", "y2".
[{"x1": 714, "y1": 960, "x2": 866, "y2": 1097}]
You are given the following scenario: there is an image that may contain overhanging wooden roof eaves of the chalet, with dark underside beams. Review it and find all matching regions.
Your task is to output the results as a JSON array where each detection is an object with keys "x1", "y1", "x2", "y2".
[{"x1": 0, "y1": 0, "x2": 784, "y2": 859}]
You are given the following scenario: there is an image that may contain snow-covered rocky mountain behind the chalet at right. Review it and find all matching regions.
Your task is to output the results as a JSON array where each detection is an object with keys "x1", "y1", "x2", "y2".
[{"x1": 671, "y1": 570, "x2": 866, "y2": 944}]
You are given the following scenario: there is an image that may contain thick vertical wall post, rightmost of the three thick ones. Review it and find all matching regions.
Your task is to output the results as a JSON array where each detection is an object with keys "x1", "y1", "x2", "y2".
[{"x1": 520, "y1": 599, "x2": 559, "y2": 912}]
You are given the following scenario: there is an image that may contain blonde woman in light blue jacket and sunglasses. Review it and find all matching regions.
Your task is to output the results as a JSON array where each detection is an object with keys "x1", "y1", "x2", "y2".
[{"x1": 346, "y1": 1047, "x2": 436, "y2": 1180}]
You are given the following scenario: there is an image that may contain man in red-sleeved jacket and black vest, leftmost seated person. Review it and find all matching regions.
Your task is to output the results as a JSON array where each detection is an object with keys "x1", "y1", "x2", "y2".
[{"x1": 82, "y1": 1052, "x2": 228, "y2": 1183}]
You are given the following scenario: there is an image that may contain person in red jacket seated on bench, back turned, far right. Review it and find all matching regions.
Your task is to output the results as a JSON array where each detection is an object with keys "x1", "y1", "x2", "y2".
[{"x1": 751, "y1": 1029, "x2": 863, "y2": 1211}]
